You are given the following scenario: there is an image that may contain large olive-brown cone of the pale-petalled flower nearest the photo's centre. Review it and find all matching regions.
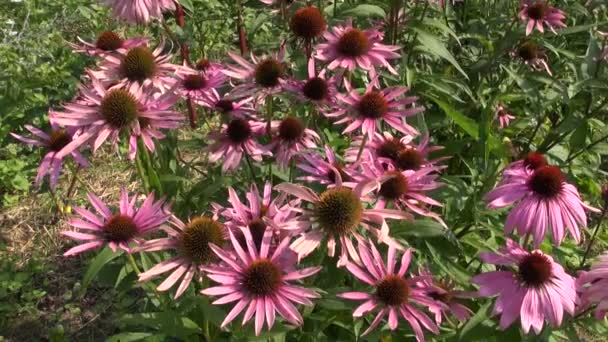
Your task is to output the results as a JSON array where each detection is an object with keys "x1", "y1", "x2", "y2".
[{"x1": 314, "y1": 187, "x2": 363, "y2": 235}]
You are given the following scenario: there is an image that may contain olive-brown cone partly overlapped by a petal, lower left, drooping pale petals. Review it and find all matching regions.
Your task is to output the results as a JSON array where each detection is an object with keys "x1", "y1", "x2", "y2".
[{"x1": 180, "y1": 217, "x2": 224, "y2": 265}]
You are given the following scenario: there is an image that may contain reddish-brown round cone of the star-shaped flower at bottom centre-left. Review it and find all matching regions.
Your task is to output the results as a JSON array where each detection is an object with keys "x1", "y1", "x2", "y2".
[{"x1": 241, "y1": 258, "x2": 283, "y2": 297}]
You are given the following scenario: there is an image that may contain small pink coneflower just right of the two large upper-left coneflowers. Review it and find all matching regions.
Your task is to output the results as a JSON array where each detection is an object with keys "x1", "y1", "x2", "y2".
[{"x1": 175, "y1": 65, "x2": 226, "y2": 101}]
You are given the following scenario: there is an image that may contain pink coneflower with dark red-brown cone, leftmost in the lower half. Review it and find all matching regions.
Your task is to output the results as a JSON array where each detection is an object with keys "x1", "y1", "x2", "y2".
[{"x1": 61, "y1": 190, "x2": 170, "y2": 256}]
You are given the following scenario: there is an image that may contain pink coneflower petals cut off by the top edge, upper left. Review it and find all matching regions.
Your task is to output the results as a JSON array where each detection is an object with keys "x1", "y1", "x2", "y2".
[{"x1": 105, "y1": 0, "x2": 175, "y2": 24}]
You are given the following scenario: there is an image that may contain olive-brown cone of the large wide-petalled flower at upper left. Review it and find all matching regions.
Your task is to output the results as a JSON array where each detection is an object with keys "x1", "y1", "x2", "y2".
[{"x1": 99, "y1": 89, "x2": 139, "y2": 129}]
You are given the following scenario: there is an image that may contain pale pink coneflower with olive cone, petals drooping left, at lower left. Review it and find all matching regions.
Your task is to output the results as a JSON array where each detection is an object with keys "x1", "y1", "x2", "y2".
[{"x1": 136, "y1": 216, "x2": 228, "y2": 298}]
